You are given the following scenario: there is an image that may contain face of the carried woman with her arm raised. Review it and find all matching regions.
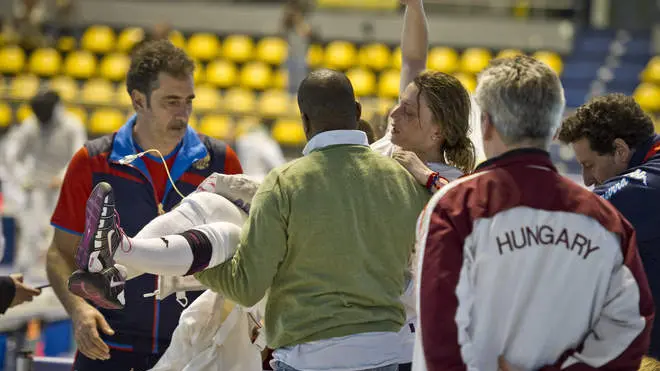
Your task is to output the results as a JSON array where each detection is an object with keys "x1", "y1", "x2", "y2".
[{"x1": 390, "y1": 83, "x2": 440, "y2": 153}]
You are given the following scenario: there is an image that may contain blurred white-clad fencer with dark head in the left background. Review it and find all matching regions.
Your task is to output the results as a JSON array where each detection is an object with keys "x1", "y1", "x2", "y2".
[{"x1": 4, "y1": 90, "x2": 87, "y2": 277}]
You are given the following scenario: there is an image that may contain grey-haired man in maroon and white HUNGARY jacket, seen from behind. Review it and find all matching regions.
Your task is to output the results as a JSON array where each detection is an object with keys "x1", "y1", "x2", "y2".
[{"x1": 413, "y1": 56, "x2": 654, "y2": 371}]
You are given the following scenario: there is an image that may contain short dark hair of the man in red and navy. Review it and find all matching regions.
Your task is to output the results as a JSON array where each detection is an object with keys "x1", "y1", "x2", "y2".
[{"x1": 126, "y1": 39, "x2": 195, "y2": 105}]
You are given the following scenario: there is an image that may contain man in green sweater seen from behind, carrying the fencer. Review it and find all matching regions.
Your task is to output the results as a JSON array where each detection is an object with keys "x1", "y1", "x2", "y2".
[{"x1": 73, "y1": 70, "x2": 429, "y2": 371}]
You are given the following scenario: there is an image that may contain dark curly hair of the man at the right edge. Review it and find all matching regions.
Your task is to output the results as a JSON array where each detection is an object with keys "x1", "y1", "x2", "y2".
[{"x1": 557, "y1": 93, "x2": 655, "y2": 155}]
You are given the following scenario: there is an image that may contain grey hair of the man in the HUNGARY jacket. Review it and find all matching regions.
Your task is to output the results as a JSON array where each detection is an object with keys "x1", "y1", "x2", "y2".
[{"x1": 476, "y1": 55, "x2": 566, "y2": 145}]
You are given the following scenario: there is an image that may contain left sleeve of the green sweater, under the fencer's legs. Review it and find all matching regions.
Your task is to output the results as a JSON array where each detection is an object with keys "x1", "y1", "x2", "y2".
[{"x1": 195, "y1": 171, "x2": 289, "y2": 307}]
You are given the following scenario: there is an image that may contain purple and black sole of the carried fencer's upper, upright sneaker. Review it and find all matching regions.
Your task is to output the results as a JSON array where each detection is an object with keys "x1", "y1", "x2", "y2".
[{"x1": 76, "y1": 182, "x2": 112, "y2": 271}]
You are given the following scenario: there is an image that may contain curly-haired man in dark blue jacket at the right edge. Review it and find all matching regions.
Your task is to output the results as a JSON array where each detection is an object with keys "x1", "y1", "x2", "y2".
[{"x1": 558, "y1": 94, "x2": 660, "y2": 359}]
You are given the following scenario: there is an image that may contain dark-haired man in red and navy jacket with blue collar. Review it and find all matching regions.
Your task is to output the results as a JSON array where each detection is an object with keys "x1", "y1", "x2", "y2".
[{"x1": 47, "y1": 40, "x2": 242, "y2": 371}]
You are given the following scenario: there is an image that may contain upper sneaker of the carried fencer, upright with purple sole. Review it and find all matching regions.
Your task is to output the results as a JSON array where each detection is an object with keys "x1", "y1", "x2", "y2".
[{"x1": 76, "y1": 182, "x2": 130, "y2": 273}]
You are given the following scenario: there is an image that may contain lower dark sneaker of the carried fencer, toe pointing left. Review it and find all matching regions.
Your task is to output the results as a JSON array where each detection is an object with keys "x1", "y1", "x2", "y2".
[{"x1": 69, "y1": 266, "x2": 126, "y2": 309}]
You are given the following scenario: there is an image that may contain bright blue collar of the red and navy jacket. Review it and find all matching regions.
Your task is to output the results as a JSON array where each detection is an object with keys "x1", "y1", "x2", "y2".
[{"x1": 110, "y1": 115, "x2": 209, "y2": 205}]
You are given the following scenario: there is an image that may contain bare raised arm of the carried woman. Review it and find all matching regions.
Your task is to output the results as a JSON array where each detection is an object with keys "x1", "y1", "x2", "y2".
[{"x1": 399, "y1": 0, "x2": 429, "y2": 93}]
